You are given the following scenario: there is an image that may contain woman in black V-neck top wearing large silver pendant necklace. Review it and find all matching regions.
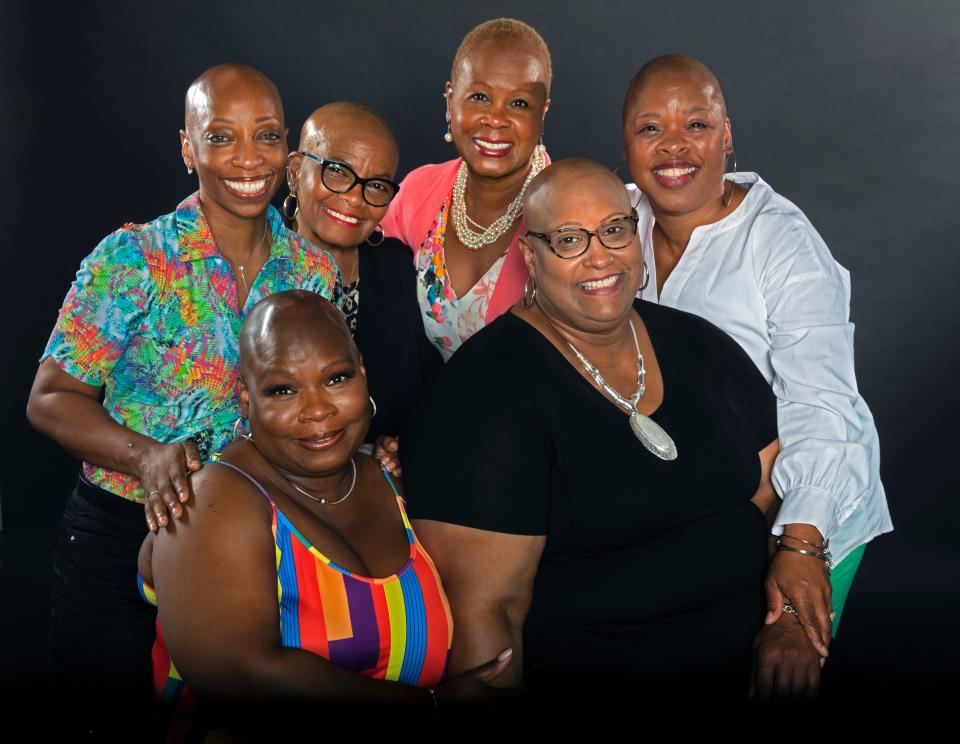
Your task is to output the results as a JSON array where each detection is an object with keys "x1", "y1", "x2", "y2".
[{"x1": 404, "y1": 160, "x2": 819, "y2": 708}]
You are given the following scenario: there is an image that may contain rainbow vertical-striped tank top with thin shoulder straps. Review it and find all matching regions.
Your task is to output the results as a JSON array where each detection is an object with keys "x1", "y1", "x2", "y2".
[{"x1": 138, "y1": 460, "x2": 453, "y2": 703}]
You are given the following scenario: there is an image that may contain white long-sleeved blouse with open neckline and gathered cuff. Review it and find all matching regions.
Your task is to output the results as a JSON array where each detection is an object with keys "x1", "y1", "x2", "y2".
[{"x1": 627, "y1": 173, "x2": 893, "y2": 562}]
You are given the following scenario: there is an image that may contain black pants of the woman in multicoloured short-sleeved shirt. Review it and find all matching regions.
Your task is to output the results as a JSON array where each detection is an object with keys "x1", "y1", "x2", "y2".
[{"x1": 50, "y1": 477, "x2": 156, "y2": 741}]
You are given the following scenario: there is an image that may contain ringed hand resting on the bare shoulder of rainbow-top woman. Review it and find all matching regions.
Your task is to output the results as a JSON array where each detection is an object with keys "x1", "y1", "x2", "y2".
[{"x1": 137, "y1": 439, "x2": 203, "y2": 532}]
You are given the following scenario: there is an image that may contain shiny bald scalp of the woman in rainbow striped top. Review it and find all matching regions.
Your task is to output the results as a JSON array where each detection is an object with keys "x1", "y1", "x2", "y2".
[{"x1": 240, "y1": 289, "x2": 359, "y2": 377}]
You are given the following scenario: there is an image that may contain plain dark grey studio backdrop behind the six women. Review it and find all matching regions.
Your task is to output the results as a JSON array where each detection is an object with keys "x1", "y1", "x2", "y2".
[{"x1": 0, "y1": 0, "x2": 960, "y2": 704}]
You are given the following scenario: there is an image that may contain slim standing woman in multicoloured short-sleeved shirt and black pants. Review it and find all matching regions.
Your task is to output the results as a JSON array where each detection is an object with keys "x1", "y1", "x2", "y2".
[{"x1": 28, "y1": 65, "x2": 340, "y2": 730}]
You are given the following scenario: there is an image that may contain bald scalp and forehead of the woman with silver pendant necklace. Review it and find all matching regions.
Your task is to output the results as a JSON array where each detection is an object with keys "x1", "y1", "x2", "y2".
[{"x1": 523, "y1": 158, "x2": 633, "y2": 232}]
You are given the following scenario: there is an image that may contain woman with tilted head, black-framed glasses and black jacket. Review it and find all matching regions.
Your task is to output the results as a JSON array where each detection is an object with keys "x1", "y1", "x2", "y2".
[{"x1": 283, "y1": 102, "x2": 441, "y2": 456}]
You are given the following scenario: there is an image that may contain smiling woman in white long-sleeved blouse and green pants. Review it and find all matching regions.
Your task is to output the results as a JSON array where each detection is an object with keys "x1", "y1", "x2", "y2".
[{"x1": 623, "y1": 56, "x2": 893, "y2": 686}]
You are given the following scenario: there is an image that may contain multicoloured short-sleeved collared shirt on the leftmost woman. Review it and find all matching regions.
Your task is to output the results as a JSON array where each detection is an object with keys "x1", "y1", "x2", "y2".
[{"x1": 41, "y1": 194, "x2": 341, "y2": 501}]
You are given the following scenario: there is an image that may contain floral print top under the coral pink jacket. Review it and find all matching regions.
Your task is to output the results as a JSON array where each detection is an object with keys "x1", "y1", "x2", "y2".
[{"x1": 413, "y1": 196, "x2": 504, "y2": 362}]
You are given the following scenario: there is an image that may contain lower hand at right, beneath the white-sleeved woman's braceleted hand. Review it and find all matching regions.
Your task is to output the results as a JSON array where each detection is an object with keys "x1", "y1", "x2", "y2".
[{"x1": 750, "y1": 614, "x2": 824, "y2": 702}]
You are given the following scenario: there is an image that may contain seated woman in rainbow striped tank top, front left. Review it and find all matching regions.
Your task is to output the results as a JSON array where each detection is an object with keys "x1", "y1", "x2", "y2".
[{"x1": 139, "y1": 291, "x2": 510, "y2": 734}]
